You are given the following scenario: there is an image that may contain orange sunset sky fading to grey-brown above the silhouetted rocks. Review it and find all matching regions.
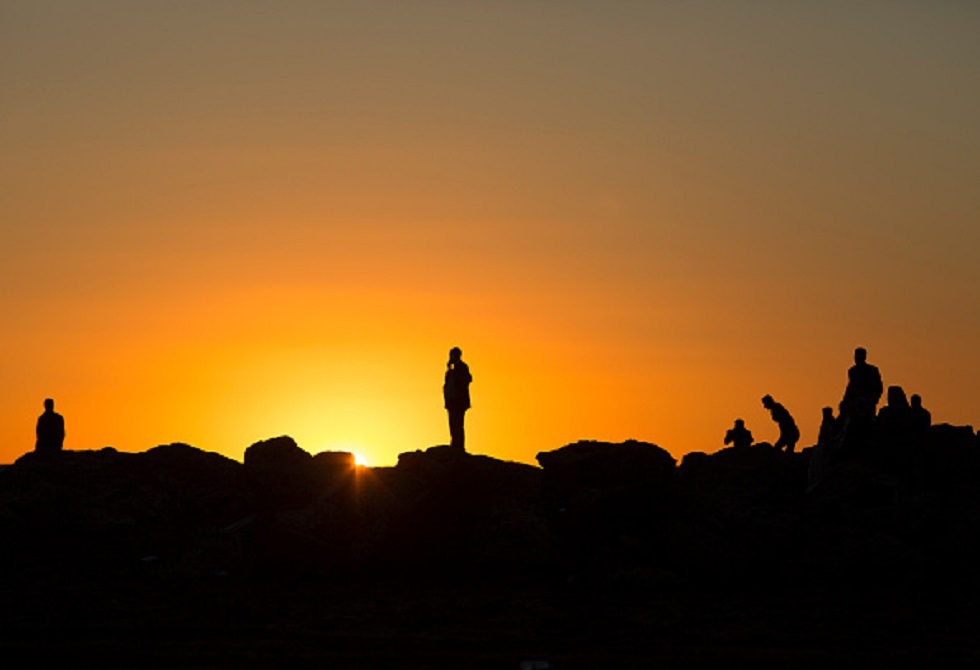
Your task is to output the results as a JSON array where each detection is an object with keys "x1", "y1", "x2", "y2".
[{"x1": 0, "y1": 0, "x2": 980, "y2": 465}]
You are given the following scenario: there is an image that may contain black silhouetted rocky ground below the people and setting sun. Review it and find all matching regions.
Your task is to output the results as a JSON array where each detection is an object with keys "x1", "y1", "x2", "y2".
[{"x1": 0, "y1": 426, "x2": 980, "y2": 669}]
